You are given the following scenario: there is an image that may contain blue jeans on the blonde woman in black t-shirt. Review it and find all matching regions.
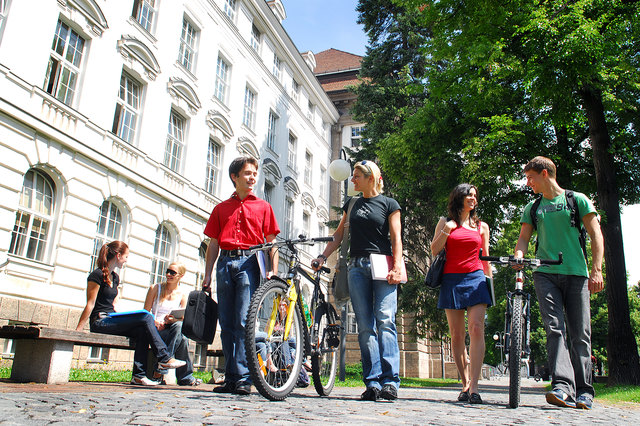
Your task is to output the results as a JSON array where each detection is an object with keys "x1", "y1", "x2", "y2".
[{"x1": 349, "y1": 257, "x2": 400, "y2": 389}]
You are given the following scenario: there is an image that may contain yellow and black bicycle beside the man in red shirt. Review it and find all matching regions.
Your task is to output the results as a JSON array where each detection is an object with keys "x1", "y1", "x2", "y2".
[{"x1": 245, "y1": 235, "x2": 341, "y2": 401}]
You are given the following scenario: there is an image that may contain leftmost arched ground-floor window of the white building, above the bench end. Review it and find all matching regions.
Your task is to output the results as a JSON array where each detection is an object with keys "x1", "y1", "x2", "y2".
[{"x1": 9, "y1": 170, "x2": 55, "y2": 262}]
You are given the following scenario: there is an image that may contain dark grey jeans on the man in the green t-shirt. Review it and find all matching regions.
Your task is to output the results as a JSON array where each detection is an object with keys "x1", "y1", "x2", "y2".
[{"x1": 533, "y1": 272, "x2": 594, "y2": 400}]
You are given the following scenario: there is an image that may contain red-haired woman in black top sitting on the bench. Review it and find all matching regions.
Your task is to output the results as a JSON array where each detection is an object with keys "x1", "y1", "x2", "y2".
[{"x1": 76, "y1": 241, "x2": 185, "y2": 386}]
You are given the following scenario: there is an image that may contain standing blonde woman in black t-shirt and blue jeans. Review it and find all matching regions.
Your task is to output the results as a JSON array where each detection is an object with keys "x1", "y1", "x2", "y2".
[{"x1": 312, "y1": 161, "x2": 403, "y2": 401}]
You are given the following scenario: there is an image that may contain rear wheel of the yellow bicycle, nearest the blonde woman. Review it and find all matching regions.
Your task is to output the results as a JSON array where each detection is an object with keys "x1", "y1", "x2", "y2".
[{"x1": 311, "y1": 303, "x2": 340, "y2": 396}]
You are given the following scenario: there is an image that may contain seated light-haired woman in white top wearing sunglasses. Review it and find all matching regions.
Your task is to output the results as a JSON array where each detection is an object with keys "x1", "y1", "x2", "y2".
[{"x1": 144, "y1": 262, "x2": 202, "y2": 386}]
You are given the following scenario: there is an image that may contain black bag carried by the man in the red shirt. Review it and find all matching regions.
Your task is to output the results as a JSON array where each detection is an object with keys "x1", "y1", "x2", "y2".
[{"x1": 182, "y1": 290, "x2": 218, "y2": 344}]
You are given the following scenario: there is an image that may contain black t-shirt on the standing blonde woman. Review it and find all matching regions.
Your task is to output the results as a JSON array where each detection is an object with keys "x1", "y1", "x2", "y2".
[{"x1": 342, "y1": 195, "x2": 400, "y2": 257}]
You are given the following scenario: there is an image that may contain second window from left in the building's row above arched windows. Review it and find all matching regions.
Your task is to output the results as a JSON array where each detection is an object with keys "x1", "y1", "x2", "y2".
[{"x1": 111, "y1": 71, "x2": 142, "y2": 143}]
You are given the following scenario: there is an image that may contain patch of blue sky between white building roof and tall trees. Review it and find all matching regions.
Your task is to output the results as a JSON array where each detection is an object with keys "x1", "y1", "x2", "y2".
[{"x1": 282, "y1": 0, "x2": 367, "y2": 56}]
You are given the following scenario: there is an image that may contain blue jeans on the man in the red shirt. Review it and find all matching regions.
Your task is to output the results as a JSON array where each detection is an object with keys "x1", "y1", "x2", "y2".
[{"x1": 216, "y1": 256, "x2": 260, "y2": 383}]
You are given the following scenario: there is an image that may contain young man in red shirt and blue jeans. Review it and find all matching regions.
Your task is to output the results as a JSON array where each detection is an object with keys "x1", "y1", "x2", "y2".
[{"x1": 202, "y1": 157, "x2": 280, "y2": 395}]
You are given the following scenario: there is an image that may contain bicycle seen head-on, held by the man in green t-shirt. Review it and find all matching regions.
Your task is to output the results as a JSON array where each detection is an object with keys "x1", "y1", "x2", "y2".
[{"x1": 480, "y1": 249, "x2": 562, "y2": 408}]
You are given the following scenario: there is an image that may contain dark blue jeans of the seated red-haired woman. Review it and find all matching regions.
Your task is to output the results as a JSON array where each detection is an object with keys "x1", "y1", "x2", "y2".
[{"x1": 90, "y1": 314, "x2": 171, "y2": 378}]
